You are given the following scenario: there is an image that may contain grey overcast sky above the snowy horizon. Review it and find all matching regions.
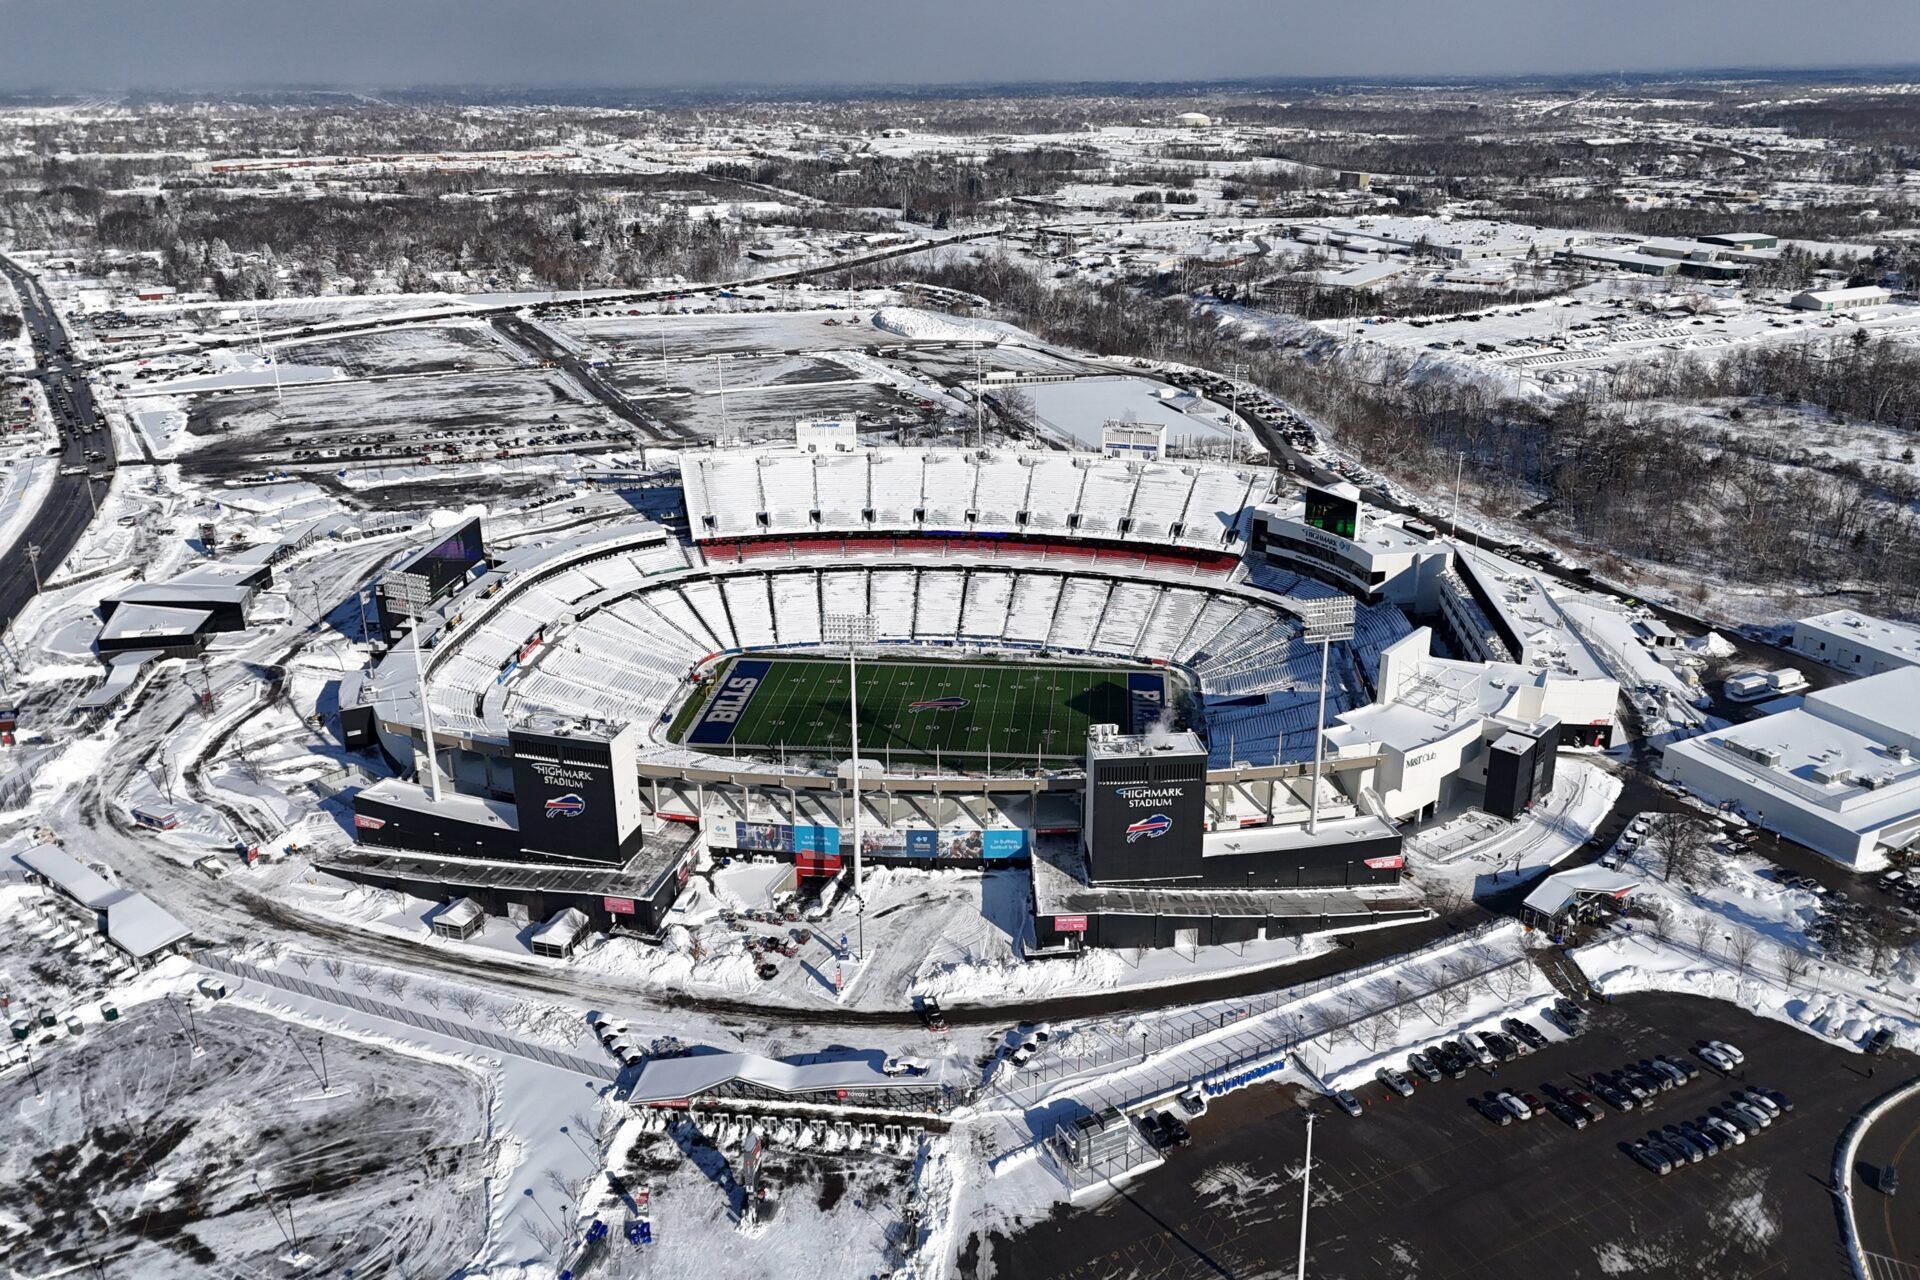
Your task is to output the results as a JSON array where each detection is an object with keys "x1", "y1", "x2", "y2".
[{"x1": 0, "y1": 0, "x2": 1920, "y2": 90}]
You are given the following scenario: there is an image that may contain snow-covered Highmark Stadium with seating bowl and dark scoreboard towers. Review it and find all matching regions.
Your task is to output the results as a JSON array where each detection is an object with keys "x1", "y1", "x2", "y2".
[{"x1": 328, "y1": 445, "x2": 1615, "y2": 950}]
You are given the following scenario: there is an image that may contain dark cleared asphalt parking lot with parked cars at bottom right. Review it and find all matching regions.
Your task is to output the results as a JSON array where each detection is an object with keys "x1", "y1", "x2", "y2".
[{"x1": 990, "y1": 994, "x2": 1912, "y2": 1280}]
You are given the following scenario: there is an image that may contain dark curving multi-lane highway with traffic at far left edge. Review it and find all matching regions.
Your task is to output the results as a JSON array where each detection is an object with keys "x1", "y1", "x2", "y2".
[{"x1": 0, "y1": 257, "x2": 115, "y2": 633}]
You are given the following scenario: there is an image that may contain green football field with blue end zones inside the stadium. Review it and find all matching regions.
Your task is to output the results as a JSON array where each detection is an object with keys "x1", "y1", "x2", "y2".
[{"x1": 682, "y1": 658, "x2": 1167, "y2": 762}]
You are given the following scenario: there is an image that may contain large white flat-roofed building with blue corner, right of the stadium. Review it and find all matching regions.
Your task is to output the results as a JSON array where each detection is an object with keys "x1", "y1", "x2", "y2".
[{"x1": 1665, "y1": 666, "x2": 1920, "y2": 871}]
